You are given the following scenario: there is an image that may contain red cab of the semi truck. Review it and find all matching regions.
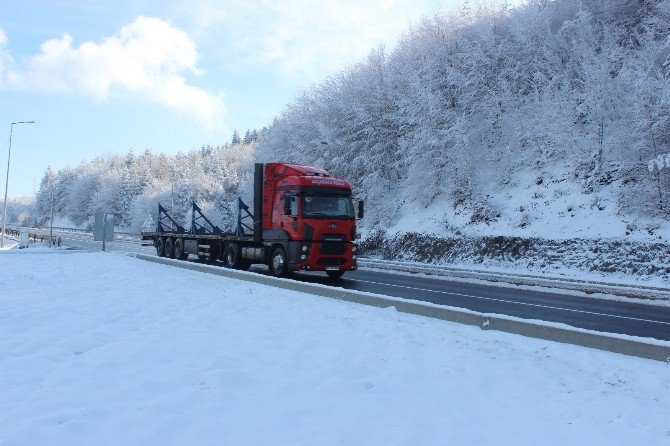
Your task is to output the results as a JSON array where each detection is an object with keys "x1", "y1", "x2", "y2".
[{"x1": 262, "y1": 163, "x2": 363, "y2": 277}]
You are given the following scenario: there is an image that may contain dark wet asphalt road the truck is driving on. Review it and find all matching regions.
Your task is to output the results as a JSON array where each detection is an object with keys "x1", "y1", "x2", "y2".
[{"x1": 23, "y1": 233, "x2": 670, "y2": 341}]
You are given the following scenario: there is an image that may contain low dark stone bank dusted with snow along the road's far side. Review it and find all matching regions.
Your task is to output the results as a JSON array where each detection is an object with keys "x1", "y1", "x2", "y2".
[{"x1": 360, "y1": 232, "x2": 670, "y2": 287}]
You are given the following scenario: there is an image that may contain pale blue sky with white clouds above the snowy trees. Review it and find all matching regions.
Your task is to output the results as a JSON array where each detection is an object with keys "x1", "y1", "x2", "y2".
[{"x1": 0, "y1": 0, "x2": 515, "y2": 197}]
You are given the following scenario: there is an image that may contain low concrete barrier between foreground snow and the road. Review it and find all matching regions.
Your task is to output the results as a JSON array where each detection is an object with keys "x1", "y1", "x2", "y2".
[{"x1": 128, "y1": 254, "x2": 670, "y2": 362}]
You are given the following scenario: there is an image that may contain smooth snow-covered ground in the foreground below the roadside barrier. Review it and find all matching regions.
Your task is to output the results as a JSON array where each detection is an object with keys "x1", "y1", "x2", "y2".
[{"x1": 0, "y1": 249, "x2": 670, "y2": 445}]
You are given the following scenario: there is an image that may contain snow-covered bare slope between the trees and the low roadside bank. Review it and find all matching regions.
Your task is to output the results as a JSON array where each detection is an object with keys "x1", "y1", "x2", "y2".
[{"x1": 386, "y1": 166, "x2": 670, "y2": 243}]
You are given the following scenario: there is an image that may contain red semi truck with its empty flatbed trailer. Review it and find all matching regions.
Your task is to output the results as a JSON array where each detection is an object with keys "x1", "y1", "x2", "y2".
[{"x1": 142, "y1": 163, "x2": 364, "y2": 278}]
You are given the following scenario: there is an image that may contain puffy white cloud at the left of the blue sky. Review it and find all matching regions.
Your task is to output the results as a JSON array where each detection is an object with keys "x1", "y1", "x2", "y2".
[{"x1": 0, "y1": 16, "x2": 224, "y2": 124}]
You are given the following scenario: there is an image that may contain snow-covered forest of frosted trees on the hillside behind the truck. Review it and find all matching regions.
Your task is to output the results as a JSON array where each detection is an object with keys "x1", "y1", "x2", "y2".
[{"x1": 16, "y1": 0, "x2": 670, "y2": 237}]
